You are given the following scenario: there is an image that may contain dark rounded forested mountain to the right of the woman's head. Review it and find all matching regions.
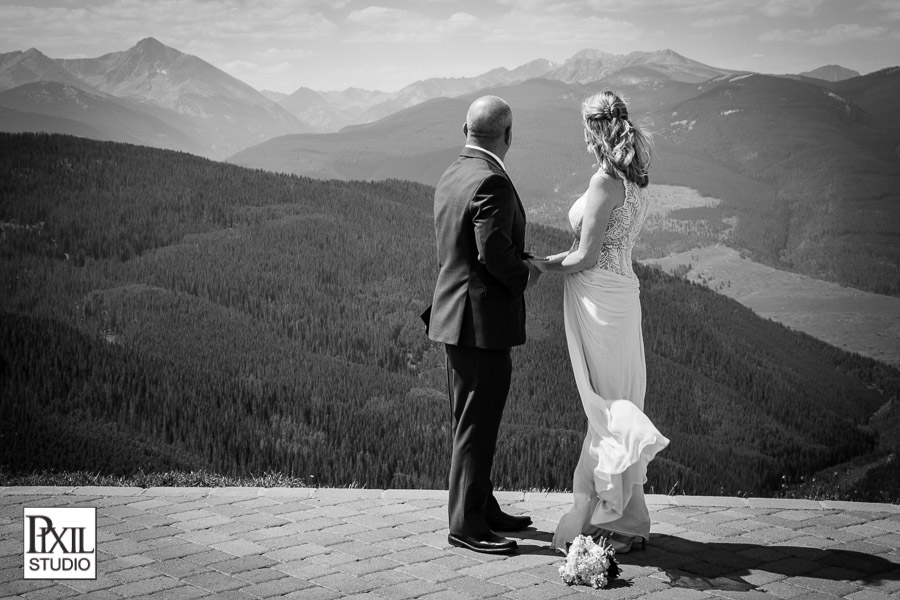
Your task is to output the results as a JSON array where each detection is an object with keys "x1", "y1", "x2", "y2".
[{"x1": 655, "y1": 74, "x2": 900, "y2": 296}]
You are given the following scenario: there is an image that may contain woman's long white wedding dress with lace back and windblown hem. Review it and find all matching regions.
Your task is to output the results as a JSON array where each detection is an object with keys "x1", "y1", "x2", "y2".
[{"x1": 553, "y1": 176, "x2": 669, "y2": 552}]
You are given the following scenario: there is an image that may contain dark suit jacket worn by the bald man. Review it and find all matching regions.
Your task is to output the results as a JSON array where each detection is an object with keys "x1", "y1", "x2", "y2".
[{"x1": 428, "y1": 148, "x2": 528, "y2": 349}]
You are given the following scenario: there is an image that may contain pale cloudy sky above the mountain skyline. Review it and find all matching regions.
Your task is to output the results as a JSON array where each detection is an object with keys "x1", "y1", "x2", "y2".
[{"x1": 0, "y1": 0, "x2": 900, "y2": 93}]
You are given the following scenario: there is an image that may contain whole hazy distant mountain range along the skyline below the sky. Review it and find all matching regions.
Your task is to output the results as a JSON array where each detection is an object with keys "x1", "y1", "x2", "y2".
[{"x1": 0, "y1": 38, "x2": 850, "y2": 151}]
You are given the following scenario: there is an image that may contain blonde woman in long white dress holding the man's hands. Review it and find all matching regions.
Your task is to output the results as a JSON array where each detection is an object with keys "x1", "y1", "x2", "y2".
[{"x1": 533, "y1": 91, "x2": 669, "y2": 554}]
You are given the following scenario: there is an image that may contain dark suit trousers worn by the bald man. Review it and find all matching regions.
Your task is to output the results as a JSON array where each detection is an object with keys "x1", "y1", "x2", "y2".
[{"x1": 445, "y1": 344, "x2": 512, "y2": 536}]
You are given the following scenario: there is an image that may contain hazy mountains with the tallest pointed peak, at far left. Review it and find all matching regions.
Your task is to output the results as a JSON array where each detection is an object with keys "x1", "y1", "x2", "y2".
[{"x1": 0, "y1": 38, "x2": 312, "y2": 158}]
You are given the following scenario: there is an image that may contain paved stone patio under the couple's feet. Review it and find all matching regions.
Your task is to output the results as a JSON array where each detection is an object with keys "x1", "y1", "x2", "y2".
[{"x1": 0, "y1": 487, "x2": 900, "y2": 600}]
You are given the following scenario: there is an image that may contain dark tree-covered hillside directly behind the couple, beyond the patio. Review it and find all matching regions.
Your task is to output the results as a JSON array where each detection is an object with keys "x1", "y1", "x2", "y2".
[{"x1": 0, "y1": 134, "x2": 900, "y2": 501}]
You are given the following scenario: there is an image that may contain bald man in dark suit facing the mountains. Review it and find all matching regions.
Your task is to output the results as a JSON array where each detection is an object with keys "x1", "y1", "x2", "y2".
[{"x1": 429, "y1": 96, "x2": 540, "y2": 554}]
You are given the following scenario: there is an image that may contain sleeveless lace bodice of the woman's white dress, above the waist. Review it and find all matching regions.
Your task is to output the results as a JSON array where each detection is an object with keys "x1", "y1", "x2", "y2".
[{"x1": 569, "y1": 180, "x2": 650, "y2": 279}]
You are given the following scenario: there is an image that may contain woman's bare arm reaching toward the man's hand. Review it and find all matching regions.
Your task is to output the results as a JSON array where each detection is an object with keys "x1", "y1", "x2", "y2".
[{"x1": 538, "y1": 171, "x2": 625, "y2": 273}]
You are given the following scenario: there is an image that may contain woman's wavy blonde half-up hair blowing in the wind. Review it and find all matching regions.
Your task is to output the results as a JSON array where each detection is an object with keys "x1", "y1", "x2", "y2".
[{"x1": 581, "y1": 91, "x2": 652, "y2": 187}]
